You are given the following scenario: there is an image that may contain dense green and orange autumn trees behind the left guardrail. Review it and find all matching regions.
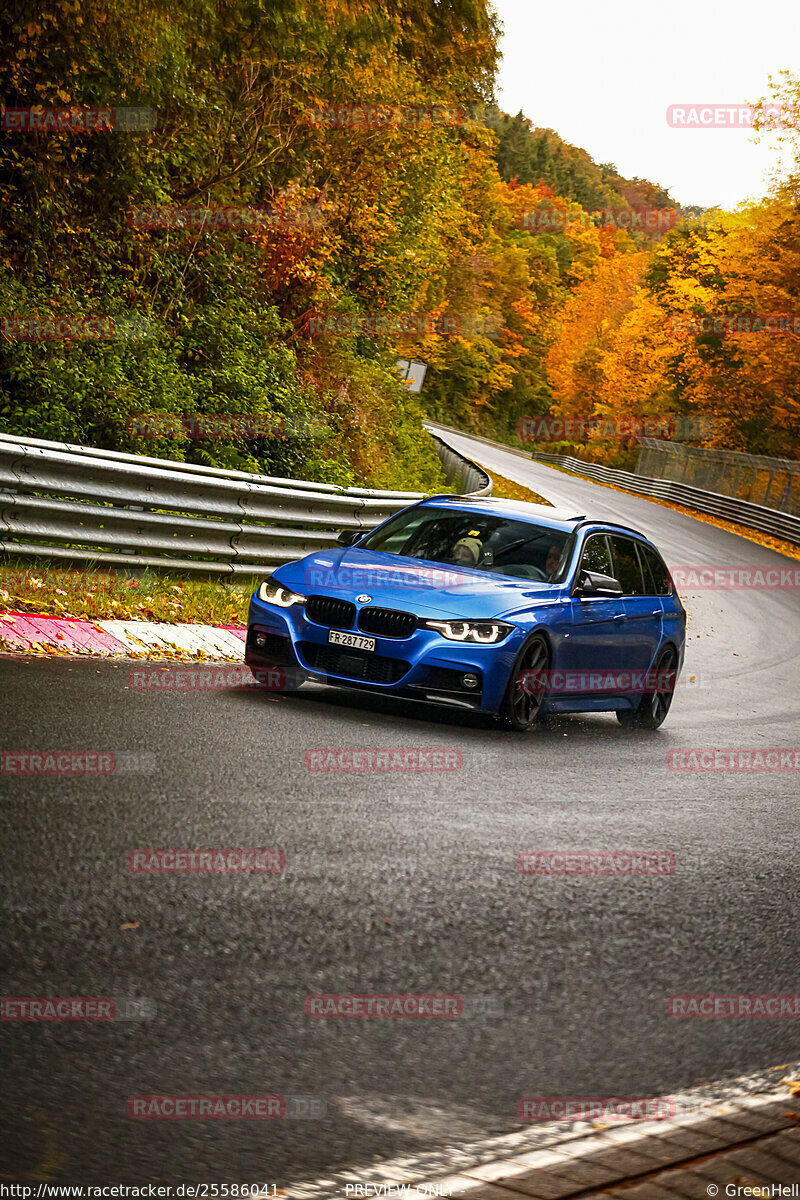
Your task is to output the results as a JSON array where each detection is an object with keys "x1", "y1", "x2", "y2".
[{"x1": 0, "y1": 0, "x2": 482, "y2": 487}]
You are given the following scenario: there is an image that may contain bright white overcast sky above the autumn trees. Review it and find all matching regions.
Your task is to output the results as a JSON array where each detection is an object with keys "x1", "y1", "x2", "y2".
[{"x1": 494, "y1": 0, "x2": 800, "y2": 208}]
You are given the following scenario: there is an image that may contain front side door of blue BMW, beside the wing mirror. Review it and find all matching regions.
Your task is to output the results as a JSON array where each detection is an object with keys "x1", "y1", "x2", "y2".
[{"x1": 560, "y1": 533, "x2": 625, "y2": 691}]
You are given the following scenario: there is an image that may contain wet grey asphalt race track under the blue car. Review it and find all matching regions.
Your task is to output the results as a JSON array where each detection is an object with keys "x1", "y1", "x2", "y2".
[{"x1": 0, "y1": 439, "x2": 800, "y2": 1187}]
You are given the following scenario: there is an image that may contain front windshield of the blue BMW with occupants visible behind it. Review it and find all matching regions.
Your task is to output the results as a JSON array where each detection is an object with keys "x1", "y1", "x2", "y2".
[{"x1": 359, "y1": 505, "x2": 570, "y2": 583}]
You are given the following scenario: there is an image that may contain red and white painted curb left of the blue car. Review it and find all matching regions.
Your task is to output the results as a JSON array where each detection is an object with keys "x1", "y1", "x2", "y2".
[{"x1": 0, "y1": 612, "x2": 247, "y2": 662}]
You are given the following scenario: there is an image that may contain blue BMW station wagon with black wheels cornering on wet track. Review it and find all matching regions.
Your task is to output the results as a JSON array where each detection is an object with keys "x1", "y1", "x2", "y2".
[{"x1": 245, "y1": 496, "x2": 686, "y2": 731}]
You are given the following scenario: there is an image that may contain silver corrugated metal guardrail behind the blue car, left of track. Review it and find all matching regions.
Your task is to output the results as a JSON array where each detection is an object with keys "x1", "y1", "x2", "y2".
[{"x1": 0, "y1": 433, "x2": 492, "y2": 576}]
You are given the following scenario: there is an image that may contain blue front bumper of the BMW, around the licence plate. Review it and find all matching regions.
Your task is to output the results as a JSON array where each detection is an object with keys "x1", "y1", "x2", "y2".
[{"x1": 245, "y1": 596, "x2": 524, "y2": 713}]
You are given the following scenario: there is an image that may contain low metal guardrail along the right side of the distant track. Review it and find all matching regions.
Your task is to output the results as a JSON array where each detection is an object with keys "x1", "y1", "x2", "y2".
[{"x1": 531, "y1": 454, "x2": 800, "y2": 546}]
